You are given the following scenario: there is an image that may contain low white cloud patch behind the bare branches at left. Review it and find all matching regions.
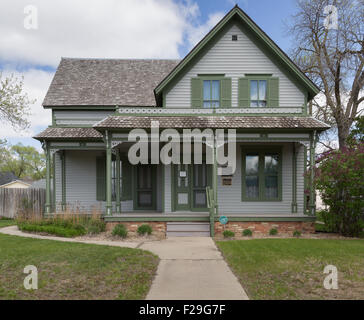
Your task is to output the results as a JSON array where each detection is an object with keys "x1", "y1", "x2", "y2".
[{"x1": 0, "y1": 69, "x2": 54, "y2": 138}]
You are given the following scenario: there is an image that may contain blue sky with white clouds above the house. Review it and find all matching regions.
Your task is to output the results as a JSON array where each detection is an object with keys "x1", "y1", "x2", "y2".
[{"x1": 0, "y1": 0, "x2": 296, "y2": 150}]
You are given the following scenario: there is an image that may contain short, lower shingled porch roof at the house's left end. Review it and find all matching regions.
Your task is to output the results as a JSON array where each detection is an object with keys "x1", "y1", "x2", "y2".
[{"x1": 33, "y1": 128, "x2": 102, "y2": 140}]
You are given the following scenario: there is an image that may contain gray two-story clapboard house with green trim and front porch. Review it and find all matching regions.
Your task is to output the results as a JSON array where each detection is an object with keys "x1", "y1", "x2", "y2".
[{"x1": 35, "y1": 6, "x2": 329, "y2": 235}]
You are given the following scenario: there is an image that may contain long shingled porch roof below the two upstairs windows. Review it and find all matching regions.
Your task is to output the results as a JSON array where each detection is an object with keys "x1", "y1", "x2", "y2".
[{"x1": 93, "y1": 116, "x2": 330, "y2": 131}]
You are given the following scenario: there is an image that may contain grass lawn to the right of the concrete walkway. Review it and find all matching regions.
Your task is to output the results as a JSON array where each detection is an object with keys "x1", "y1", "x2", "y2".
[{"x1": 217, "y1": 239, "x2": 364, "y2": 299}]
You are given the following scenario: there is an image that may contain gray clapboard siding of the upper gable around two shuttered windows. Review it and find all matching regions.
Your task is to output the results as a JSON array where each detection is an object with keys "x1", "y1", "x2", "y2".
[{"x1": 166, "y1": 25, "x2": 304, "y2": 108}]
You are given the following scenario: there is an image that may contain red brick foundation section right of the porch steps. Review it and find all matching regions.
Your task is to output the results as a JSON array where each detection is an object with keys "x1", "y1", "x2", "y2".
[{"x1": 215, "y1": 221, "x2": 315, "y2": 237}]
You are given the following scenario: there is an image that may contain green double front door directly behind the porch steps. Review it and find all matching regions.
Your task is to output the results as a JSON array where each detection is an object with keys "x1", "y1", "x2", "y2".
[{"x1": 173, "y1": 163, "x2": 211, "y2": 211}]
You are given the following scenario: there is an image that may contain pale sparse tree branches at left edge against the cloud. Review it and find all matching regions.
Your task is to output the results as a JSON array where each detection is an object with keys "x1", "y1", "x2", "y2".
[{"x1": 0, "y1": 72, "x2": 35, "y2": 130}]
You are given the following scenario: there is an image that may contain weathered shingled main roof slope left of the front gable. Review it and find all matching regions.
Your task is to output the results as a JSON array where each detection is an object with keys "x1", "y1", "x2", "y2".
[{"x1": 43, "y1": 58, "x2": 179, "y2": 107}]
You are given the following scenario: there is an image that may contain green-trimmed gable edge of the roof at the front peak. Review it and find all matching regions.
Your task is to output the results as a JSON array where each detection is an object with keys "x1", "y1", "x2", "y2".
[{"x1": 154, "y1": 5, "x2": 320, "y2": 100}]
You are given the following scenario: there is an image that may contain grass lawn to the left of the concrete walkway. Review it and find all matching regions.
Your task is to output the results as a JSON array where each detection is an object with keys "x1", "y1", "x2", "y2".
[{"x1": 0, "y1": 234, "x2": 159, "y2": 299}]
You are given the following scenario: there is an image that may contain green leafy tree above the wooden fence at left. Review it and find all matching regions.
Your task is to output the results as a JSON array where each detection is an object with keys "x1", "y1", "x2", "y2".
[{"x1": 0, "y1": 144, "x2": 46, "y2": 180}]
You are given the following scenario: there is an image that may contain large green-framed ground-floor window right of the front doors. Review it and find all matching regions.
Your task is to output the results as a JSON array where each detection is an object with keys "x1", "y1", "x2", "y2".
[{"x1": 242, "y1": 151, "x2": 281, "y2": 201}]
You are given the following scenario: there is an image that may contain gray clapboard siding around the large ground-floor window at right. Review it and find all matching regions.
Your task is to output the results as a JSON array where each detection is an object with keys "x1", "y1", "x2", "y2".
[{"x1": 218, "y1": 143, "x2": 303, "y2": 214}]
